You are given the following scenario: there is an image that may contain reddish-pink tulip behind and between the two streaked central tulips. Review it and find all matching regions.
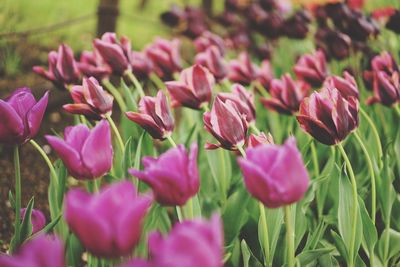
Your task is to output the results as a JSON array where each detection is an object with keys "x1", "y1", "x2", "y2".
[{"x1": 165, "y1": 64, "x2": 215, "y2": 109}]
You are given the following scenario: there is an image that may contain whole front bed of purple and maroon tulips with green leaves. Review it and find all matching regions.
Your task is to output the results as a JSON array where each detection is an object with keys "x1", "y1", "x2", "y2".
[{"x1": 0, "y1": 0, "x2": 400, "y2": 267}]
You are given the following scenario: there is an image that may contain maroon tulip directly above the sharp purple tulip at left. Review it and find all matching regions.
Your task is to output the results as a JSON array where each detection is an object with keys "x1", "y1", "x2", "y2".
[{"x1": 63, "y1": 77, "x2": 114, "y2": 120}]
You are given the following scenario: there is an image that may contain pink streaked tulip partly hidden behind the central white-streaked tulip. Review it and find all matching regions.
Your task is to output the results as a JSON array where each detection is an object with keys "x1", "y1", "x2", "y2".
[{"x1": 217, "y1": 83, "x2": 256, "y2": 124}]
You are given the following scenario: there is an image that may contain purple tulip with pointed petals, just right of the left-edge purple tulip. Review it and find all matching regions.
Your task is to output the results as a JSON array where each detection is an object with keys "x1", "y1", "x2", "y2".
[{"x1": 46, "y1": 120, "x2": 113, "y2": 179}]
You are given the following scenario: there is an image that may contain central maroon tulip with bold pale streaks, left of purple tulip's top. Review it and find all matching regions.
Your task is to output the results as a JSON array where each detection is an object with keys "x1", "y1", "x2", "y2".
[{"x1": 203, "y1": 97, "x2": 248, "y2": 150}]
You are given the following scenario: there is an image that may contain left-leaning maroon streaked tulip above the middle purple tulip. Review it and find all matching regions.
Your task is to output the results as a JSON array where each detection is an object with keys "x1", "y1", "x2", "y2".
[{"x1": 125, "y1": 91, "x2": 175, "y2": 140}]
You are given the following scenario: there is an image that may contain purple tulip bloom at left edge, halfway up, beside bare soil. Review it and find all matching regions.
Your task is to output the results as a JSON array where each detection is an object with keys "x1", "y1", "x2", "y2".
[{"x1": 0, "y1": 88, "x2": 49, "y2": 145}]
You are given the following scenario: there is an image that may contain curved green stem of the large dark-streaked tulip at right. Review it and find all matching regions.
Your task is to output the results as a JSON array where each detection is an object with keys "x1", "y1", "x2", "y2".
[{"x1": 337, "y1": 143, "x2": 358, "y2": 267}]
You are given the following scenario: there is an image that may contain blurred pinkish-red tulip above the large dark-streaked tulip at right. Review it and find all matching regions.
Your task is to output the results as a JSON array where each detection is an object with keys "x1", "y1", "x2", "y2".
[{"x1": 293, "y1": 50, "x2": 328, "y2": 86}]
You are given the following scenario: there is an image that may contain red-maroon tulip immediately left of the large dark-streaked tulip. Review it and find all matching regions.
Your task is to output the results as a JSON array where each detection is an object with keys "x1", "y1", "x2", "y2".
[{"x1": 260, "y1": 74, "x2": 310, "y2": 115}]
